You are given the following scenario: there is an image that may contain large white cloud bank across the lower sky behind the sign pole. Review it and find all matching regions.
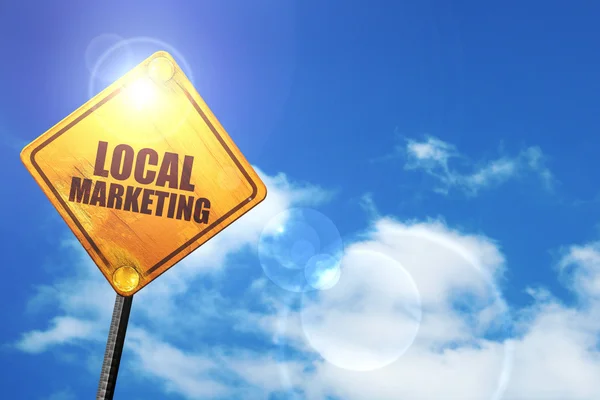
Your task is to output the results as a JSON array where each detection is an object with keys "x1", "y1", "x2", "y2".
[{"x1": 14, "y1": 170, "x2": 600, "y2": 400}]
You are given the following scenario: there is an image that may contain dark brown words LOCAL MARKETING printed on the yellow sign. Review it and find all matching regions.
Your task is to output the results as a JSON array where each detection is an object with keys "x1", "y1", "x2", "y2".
[{"x1": 69, "y1": 142, "x2": 210, "y2": 224}]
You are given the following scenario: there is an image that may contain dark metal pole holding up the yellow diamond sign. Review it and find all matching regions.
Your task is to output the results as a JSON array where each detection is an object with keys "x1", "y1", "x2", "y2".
[{"x1": 96, "y1": 294, "x2": 133, "y2": 400}]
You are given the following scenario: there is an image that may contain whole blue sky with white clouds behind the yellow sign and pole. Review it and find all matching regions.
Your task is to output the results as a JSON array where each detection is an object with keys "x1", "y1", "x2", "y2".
[{"x1": 0, "y1": 0, "x2": 600, "y2": 400}]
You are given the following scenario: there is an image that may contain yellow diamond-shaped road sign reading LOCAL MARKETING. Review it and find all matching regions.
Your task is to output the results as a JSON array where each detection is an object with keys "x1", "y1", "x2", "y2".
[{"x1": 21, "y1": 52, "x2": 267, "y2": 296}]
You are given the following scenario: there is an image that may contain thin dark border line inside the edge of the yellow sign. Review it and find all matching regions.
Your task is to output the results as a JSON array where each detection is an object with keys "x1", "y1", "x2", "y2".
[{"x1": 30, "y1": 81, "x2": 258, "y2": 278}]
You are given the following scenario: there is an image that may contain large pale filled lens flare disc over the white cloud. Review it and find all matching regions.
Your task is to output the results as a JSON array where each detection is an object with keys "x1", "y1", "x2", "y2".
[{"x1": 301, "y1": 250, "x2": 421, "y2": 371}]
